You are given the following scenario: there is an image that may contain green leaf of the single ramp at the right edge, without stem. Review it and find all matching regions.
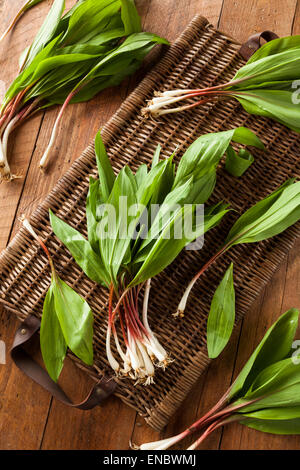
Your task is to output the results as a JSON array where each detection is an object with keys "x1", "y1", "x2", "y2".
[{"x1": 225, "y1": 181, "x2": 300, "y2": 246}]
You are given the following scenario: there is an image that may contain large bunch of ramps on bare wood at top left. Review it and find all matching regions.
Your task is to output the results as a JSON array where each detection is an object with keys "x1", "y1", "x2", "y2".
[{"x1": 0, "y1": 0, "x2": 168, "y2": 182}]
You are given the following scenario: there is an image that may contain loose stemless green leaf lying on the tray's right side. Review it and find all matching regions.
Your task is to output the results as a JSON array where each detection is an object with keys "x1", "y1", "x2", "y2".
[{"x1": 207, "y1": 263, "x2": 235, "y2": 358}]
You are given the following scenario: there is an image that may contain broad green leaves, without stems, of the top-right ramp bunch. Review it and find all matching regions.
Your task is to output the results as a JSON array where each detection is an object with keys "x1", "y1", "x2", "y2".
[{"x1": 226, "y1": 35, "x2": 300, "y2": 132}]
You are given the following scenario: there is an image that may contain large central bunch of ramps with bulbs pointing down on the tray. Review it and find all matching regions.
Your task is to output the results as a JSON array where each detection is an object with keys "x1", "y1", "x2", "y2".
[{"x1": 21, "y1": 128, "x2": 263, "y2": 384}]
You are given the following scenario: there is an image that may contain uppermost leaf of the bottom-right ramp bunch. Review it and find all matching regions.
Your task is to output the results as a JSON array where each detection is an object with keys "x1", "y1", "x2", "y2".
[{"x1": 229, "y1": 309, "x2": 299, "y2": 399}]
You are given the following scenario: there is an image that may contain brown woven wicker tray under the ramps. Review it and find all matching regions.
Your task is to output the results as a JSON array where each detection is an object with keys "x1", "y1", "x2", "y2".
[{"x1": 0, "y1": 16, "x2": 300, "y2": 430}]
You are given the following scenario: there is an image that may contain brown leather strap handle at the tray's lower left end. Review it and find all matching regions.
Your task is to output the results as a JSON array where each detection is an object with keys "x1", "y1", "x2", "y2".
[{"x1": 11, "y1": 315, "x2": 117, "y2": 410}]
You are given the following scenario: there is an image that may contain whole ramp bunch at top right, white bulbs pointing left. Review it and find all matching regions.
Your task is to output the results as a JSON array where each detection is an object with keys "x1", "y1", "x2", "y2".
[{"x1": 143, "y1": 35, "x2": 300, "y2": 132}]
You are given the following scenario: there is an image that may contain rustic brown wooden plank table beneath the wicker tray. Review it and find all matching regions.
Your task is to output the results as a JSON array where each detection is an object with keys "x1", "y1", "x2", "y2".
[{"x1": 0, "y1": 0, "x2": 300, "y2": 450}]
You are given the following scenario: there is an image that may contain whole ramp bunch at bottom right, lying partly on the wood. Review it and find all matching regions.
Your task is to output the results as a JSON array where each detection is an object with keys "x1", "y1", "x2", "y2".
[{"x1": 132, "y1": 308, "x2": 300, "y2": 450}]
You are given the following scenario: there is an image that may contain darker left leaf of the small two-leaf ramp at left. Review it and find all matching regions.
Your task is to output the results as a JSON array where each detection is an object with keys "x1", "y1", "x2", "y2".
[{"x1": 40, "y1": 281, "x2": 67, "y2": 382}]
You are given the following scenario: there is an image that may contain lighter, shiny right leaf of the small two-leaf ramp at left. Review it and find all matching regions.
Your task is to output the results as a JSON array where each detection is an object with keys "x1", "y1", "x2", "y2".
[{"x1": 52, "y1": 275, "x2": 93, "y2": 365}]
